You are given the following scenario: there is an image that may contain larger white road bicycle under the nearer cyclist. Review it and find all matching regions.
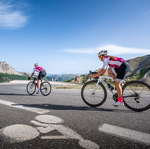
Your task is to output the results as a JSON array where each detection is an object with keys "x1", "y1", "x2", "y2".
[{"x1": 81, "y1": 72, "x2": 150, "y2": 112}]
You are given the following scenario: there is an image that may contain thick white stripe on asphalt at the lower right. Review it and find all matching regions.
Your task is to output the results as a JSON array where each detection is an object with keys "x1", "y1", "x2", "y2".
[{"x1": 98, "y1": 124, "x2": 150, "y2": 144}]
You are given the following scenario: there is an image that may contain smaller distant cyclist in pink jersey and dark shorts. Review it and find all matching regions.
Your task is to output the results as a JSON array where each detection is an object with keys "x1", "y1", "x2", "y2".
[{"x1": 28, "y1": 63, "x2": 46, "y2": 94}]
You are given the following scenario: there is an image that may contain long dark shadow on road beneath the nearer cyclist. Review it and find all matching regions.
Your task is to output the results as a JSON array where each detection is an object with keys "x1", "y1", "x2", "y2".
[{"x1": 13, "y1": 104, "x2": 135, "y2": 113}]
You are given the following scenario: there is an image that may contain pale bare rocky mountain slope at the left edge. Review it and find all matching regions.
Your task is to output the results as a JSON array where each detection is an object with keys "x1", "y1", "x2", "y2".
[{"x1": 0, "y1": 62, "x2": 21, "y2": 75}]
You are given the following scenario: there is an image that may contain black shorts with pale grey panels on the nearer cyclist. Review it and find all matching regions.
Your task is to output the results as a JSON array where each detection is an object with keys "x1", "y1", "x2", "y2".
[{"x1": 114, "y1": 62, "x2": 131, "y2": 82}]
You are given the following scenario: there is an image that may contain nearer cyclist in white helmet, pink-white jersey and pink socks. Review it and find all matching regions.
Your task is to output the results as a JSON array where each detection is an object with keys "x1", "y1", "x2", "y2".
[{"x1": 90, "y1": 50, "x2": 131, "y2": 107}]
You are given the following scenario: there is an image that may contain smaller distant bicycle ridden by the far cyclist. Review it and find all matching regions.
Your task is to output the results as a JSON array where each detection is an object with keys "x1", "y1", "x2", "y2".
[{"x1": 26, "y1": 77, "x2": 52, "y2": 96}]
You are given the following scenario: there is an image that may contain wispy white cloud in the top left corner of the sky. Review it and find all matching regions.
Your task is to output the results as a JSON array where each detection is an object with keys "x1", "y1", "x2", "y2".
[{"x1": 0, "y1": 2, "x2": 28, "y2": 29}]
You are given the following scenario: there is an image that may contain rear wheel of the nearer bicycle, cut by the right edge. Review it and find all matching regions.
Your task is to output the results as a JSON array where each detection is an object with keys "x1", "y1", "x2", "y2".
[{"x1": 123, "y1": 81, "x2": 150, "y2": 112}]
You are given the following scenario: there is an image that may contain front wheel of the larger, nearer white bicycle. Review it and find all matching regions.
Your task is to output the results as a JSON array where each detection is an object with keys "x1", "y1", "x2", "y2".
[{"x1": 81, "y1": 80, "x2": 107, "y2": 107}]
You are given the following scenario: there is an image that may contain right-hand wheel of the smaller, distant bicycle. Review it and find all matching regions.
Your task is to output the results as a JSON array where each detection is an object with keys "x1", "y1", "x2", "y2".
[{"x1": 40, "y1": 82, "x2": 52, "y2": 96}]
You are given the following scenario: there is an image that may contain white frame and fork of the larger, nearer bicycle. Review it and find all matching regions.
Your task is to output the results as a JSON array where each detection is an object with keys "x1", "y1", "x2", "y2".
[{"x1": 93, "y1": 76, "x2": 114, "y2": 94}]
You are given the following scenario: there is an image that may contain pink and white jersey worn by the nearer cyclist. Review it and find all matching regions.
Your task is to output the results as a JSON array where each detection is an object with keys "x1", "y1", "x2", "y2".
[{"x1": 103, "y1": 57, "x2": 126, "y2": 69}]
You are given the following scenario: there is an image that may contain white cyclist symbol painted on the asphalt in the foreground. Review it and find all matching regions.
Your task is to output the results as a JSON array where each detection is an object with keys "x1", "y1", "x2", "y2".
[{"x1": 0, "y1": 115, "x2": 99, "y2": 149}]
